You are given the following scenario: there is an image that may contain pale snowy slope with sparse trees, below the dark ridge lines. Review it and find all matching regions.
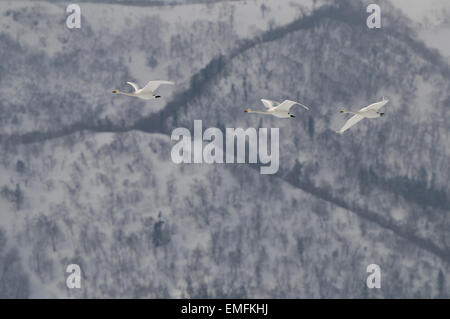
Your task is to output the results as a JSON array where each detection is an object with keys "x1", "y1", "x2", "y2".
[{"x1": 0, "y1": 132, "x2": 446, "y2": 298}]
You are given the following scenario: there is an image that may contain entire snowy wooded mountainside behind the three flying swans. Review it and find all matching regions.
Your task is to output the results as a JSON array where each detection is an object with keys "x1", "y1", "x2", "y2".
[{"x1": 0, "y1": 0, "x2": 450, "y2": 298}]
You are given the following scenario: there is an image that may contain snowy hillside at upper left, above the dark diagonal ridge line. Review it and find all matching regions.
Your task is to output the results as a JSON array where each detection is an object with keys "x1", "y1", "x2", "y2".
[{"x1": 0, "y1": 0, "x2": 311, "y2": 135}]
